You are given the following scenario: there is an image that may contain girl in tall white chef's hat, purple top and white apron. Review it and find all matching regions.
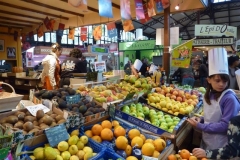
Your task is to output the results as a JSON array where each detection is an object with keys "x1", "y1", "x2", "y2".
[{"x1": 188, "y1": 48, "x2": 240, "y2": 150}]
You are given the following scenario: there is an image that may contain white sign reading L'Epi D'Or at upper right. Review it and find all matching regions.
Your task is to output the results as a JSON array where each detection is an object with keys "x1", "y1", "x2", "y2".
[{"x1": 195, "y1": 24, "x2": 237, "y2": 38}]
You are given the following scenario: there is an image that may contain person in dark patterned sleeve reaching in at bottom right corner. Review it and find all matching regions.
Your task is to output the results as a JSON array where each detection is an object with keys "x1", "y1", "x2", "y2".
[{"x1": 192, "y1": 115, "x2": 240, "y2": 160}]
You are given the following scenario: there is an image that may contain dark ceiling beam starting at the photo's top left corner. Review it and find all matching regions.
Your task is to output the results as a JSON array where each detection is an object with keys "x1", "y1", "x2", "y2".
[{"x1": 0, "y1": 1, "x2": 69, "y2": 20}]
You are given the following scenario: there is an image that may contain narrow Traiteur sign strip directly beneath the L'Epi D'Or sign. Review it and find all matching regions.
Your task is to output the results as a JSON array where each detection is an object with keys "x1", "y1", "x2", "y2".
[{"x1": 193, "y1": 38, "x2": 233, "y2": 46}]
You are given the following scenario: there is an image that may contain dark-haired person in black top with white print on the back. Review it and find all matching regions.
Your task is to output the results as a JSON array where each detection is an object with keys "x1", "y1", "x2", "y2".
[{"x1": 60, "y1": 48, "x2": 87, "y2": 87}]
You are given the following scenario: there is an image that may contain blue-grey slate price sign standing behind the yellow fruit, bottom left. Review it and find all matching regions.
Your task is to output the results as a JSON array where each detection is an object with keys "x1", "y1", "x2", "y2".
[{"x1": 45, "y1": 124, "x2": 69, "y2": 147}]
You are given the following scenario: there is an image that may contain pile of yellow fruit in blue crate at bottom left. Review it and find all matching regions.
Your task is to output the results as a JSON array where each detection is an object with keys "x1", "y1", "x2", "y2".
[{"x1": 30, "y1": 130, "x2": 97, "y2": 160}]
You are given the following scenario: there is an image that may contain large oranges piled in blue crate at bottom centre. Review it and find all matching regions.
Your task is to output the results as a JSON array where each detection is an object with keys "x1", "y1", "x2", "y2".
[{"x1": 85, "y1": 120, "x2": 166, "y2": 160}]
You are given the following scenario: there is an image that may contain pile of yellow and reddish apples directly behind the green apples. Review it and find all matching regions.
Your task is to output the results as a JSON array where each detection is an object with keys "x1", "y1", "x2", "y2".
[{"x1": 147, "y1": 86, "x2": 199, "y2": 116}]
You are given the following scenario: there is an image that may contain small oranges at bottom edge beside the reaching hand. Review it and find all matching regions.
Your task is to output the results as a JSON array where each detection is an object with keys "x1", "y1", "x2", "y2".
[{"x1": 168, "y1": 149, "x2": 207, "y2": 160}]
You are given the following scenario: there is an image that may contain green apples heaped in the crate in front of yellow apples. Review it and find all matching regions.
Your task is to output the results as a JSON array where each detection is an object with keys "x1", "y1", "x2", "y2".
[{"x1": 121, "y1": 103, "x2": 180, "y2": 133}]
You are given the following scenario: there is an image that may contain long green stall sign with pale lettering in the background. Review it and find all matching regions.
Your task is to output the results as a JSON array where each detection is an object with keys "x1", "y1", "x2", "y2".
[{"x1": 119, "y1": 40, "x2": 156, "y2": 51}]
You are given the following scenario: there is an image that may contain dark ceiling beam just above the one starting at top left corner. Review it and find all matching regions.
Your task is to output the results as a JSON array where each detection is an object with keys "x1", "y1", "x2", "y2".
[{"x1": 21, "y1": 0, "x2": 84, "y2": 17}]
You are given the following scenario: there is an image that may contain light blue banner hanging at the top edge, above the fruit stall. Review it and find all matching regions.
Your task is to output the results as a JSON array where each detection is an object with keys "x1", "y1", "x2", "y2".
[{"x1": 98, "y1": 0, "x2": 113, "y2": 18}]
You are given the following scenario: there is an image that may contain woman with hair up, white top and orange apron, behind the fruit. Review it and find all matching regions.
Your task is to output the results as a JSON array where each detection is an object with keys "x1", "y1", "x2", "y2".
[{"x1": 41, "y1": 43, "x2": 62, "y2": 90}]
